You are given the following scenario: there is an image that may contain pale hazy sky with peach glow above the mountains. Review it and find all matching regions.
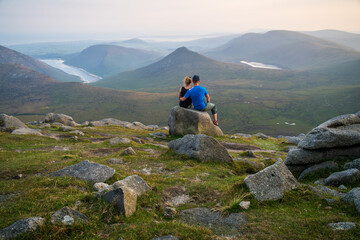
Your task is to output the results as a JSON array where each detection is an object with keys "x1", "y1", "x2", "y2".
[{"x1": 0, "y1": 0, "x2": 360, "y2": 44}]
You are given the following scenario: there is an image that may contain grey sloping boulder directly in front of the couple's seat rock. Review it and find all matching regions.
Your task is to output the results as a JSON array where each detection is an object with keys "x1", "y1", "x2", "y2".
[{"x1": 169, "y1": 134, "x2": 232, "y2": 162}]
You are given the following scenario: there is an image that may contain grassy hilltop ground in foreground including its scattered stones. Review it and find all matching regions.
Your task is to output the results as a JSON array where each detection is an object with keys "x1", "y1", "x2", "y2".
[{"x1": 0, "y1": 113, "x2": 360, "y2": 240}]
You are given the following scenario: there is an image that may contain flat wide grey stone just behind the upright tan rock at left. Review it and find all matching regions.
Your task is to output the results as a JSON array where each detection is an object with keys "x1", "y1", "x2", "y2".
[{"x1": 49, "y1": 160, "x2": 115, "y2": 183}]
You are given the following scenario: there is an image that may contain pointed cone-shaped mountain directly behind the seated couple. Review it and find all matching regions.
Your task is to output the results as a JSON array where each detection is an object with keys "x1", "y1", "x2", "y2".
[{"x1": 92, "y1": 47, "x2": 289, "y2": 91}]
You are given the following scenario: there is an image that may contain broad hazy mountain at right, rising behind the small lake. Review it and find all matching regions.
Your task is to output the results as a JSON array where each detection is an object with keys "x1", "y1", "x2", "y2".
[{"x1": 205, "y1": 31, "x2": 360, "y2": 69}]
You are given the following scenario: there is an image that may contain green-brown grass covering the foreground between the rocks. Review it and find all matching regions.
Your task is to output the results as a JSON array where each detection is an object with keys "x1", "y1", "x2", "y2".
[{"x1": 0, "y1": 126, "x2": 360, "y2": 240}]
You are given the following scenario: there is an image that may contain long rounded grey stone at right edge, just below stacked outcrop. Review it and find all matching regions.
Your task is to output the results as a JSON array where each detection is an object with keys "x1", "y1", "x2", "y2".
[{"x1": 325, "y1": 168, "x2": 360, "y2": 186}]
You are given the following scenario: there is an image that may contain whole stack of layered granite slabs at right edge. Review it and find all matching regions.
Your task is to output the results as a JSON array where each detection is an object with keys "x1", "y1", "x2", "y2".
[{"x1": 285, "y1": 113, "x2": 360, "y2": 173}]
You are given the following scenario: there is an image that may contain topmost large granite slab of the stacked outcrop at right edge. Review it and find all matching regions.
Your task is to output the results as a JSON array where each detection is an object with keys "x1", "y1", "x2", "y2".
[{"x1": 298, "y1": 114, "x2": 360, "y2": 150}]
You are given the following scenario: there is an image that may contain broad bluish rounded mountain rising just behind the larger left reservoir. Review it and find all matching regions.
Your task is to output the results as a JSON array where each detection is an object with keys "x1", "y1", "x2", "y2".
[{"x1": 65, "y1": 45, "x2": 160, "y2": 77}]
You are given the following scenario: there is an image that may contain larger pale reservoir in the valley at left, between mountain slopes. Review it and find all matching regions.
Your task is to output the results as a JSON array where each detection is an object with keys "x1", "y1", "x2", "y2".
[{"x1": 40, "y1": 58, "x2": 102, "y2": 83}]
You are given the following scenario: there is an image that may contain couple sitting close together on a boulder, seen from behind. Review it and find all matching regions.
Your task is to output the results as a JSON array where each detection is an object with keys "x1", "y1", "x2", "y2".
[{"x1": 179, "y1": 75, "x2": 219, "y2": 126}]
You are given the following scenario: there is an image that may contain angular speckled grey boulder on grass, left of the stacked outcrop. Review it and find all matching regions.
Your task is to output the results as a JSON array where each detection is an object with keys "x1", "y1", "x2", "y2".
[{"x1": 245, "y1": 159, "x2": 299, "y2": 201}]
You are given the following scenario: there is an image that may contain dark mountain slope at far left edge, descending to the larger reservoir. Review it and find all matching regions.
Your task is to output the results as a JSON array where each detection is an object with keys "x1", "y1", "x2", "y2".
[{"x1": 0, "y1": 46, "x2": 80, "y2": 82}]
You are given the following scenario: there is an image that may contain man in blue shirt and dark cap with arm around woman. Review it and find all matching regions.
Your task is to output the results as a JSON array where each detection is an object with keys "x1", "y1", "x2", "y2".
[{"x1": 180, "y1": 75, "x2": 219, "y2": 126}]
